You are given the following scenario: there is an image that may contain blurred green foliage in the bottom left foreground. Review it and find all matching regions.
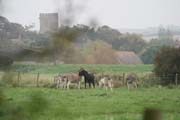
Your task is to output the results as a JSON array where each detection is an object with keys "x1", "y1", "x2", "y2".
[{"x1": 0, "y1": 89, "x2": 48, "y2": 120}]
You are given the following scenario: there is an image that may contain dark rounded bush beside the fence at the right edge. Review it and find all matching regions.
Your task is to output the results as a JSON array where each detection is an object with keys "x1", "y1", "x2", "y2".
[{"x1": 154, "y1": 47, "x2": 180, "y2": 84}]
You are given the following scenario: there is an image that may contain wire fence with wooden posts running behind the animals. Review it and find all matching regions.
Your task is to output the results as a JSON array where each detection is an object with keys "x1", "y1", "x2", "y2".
[{"x1": 0, "y1": 72, "x2": 180, "y2": 87}]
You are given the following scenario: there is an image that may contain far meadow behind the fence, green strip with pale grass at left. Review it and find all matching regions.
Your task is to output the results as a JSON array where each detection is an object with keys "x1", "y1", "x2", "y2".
[{"x1": 0, "y1": 64, "x2": 154, "y2": 86}]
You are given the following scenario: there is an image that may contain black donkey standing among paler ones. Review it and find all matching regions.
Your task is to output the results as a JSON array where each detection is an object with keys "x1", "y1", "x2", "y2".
[{"x1": 79, "y1": 68, "x2": 95, "y2": 88}]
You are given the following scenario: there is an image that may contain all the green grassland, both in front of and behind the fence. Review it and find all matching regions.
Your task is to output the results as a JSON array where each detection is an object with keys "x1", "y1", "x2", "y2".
[{"x1": 0, "y1": 64, "x2": 180, "y2": 120}]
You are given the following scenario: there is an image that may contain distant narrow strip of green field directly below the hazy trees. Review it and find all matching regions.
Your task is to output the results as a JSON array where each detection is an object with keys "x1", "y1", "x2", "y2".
[{"x1": 10, "y1": 64, "x2": 153, "y2": 74}]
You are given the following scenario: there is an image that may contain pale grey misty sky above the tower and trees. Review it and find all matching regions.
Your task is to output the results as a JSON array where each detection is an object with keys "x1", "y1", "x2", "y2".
[{"x1": 0, "y1": 0, "x2": 180, "y2": 29}]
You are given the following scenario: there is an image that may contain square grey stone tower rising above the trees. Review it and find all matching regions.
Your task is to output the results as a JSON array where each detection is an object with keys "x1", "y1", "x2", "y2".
[{"x1": 39, "y1": 13, "x2": 59, "y2": 33}]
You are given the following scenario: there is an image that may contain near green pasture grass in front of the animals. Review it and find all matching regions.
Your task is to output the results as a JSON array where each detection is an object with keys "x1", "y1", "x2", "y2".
[{"x1": 1, "y1": 88, "x2": 180, "y2": 120}]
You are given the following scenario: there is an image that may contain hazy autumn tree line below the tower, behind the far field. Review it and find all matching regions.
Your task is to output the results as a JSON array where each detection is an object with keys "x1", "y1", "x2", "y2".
[{"x1": 0, "y1": 17, "x2": 175, "y2": 64}]
